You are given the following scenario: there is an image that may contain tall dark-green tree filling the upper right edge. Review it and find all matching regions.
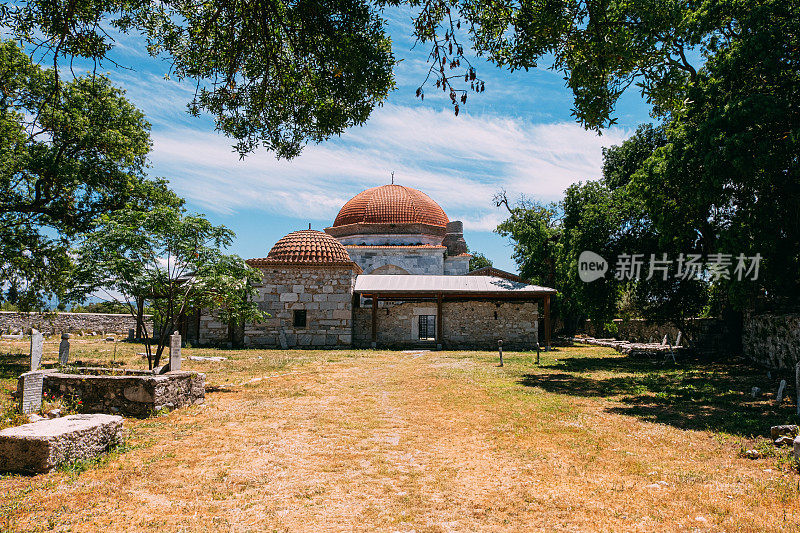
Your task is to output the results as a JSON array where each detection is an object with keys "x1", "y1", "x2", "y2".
[{"x1": 631, "y1": 1, "x2": 800, "y2": 308}]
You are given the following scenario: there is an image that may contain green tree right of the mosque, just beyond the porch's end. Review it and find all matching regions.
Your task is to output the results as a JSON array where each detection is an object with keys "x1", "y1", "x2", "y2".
[{"x1": 497, "y1": 125, "x2": 708, "y2": 332}]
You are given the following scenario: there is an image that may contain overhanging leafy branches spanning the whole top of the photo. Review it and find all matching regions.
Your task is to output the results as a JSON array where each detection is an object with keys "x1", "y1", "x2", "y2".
[{"x1": 0, "y1": 0, "x2": 748, "y2": 157}]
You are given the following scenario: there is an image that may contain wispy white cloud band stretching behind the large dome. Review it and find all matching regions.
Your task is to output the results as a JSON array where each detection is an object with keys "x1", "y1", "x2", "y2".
[{"x1": 147, "y1": 105, "x2": 629, "y2": 231}]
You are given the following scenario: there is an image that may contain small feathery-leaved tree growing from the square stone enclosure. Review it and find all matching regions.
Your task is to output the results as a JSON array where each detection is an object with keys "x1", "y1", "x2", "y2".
[{"x1": 72, "y1": 207, "x2": 264, "y2": 368}]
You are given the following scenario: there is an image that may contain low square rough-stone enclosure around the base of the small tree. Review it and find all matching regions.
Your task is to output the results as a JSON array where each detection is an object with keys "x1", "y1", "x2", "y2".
[{"x1": 40, "y1": 368, "x2": 206, "y2": 418}]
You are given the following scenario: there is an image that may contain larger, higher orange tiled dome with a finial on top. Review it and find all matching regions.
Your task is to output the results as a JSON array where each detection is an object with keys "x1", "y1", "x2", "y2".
[{"x1": 333, "y1": 185, "x2": 449, "y2": 228}]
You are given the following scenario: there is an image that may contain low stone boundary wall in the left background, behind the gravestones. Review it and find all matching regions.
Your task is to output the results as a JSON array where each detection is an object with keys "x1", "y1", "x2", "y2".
[{"x1": 0, "y1": 311, "x2": 153, "y2": 335}]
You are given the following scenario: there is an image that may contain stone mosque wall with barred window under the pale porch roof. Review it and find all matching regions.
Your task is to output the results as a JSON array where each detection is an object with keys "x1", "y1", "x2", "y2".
[{"x1": 353, "y1": 300, "x2": 539, "y2": 350}]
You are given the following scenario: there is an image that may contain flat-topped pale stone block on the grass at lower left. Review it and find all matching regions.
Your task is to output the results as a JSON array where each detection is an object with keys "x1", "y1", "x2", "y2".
[{"x1": 0, "y1": 414, "x2": 122, "y2": 474}]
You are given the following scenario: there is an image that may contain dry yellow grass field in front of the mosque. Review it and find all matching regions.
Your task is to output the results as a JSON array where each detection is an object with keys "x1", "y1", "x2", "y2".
[{"x1": 0, "y1": 338, "x2": 800, "y2": 532}]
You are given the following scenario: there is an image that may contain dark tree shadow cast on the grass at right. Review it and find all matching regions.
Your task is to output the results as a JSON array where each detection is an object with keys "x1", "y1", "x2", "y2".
[{"x1": 519, "y1": 357, "x2": 796, "y2": 436}]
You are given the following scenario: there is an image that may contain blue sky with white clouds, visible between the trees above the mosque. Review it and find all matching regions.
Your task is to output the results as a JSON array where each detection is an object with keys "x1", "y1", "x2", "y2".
[{"x1": 59, "y1": 9, "x2": 650, "y2": 271}]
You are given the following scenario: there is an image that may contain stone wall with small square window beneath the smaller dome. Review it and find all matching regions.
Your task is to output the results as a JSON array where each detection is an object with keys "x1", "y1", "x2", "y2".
[{"x1": 200, "y1": 266, "x2": 355, "y2": 348}]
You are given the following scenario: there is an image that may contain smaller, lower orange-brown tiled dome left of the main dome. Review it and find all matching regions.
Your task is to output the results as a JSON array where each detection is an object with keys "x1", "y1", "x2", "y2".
[{"x1": 247, "y1": 230, "x2": 353, "y2": 266}]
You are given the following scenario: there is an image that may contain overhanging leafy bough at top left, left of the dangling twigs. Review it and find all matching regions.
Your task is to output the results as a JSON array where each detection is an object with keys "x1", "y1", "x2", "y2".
[{"x1": 0, "y1": 0, "x2": 395, "y2": 157}]
